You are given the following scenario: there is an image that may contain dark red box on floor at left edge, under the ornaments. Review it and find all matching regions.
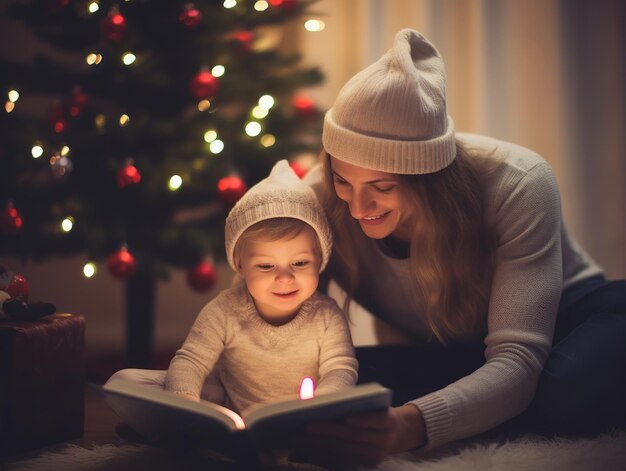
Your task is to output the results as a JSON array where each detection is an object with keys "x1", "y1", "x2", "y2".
[{"x1": 0, "y1": 314, "x2": 85, "y2": 455}]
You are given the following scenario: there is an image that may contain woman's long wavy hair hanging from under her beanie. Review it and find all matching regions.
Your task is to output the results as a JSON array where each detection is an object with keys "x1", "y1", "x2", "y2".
[{"x1": 322, "y1": 143, "x2": 497, "y2": 343}]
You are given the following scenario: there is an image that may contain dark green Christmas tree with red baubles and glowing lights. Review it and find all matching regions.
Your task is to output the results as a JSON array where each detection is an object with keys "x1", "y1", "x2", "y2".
[{"x1": 0, "y1": 0, "x2": 322, "y2": 366}]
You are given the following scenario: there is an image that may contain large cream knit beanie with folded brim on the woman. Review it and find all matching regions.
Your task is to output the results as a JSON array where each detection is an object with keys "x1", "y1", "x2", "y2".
[{"x1": 322, "y1": 29, "x2": 456, "y2": 174}]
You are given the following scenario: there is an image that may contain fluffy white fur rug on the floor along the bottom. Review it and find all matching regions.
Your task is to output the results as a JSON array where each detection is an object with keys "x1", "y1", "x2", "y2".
[{"x1": 6, "y1": 431, "x2": 626, "y2": 471}]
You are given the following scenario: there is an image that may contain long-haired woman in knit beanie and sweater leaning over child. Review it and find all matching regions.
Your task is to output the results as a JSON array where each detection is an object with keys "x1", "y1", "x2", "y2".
[{"x1": 300, "y1": 30, "x2": 626, "y2": 464}]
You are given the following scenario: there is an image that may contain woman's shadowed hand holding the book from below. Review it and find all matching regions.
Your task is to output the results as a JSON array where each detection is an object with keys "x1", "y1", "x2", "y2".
[{"x1": 294, "y1": 404, "x2": 426, "y2": 466}]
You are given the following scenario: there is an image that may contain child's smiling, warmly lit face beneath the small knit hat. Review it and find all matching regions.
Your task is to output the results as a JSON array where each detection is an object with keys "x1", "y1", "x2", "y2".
[{"x1": 239, "y1": 230, "x2": 319, "y2": 325}]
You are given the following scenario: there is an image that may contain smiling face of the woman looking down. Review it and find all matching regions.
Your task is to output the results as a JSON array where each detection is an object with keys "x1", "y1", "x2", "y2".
[{"x1": 330, "y1": 156, "x2": 411, "y2": 240}]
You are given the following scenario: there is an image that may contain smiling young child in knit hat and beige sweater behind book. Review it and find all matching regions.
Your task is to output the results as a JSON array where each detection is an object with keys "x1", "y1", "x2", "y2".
[{"x1": 111, "y1": 160, "x2": 357, "y2": 413}]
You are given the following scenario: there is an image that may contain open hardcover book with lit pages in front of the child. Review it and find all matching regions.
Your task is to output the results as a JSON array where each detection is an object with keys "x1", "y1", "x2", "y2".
[{"x1": 94, "y1": 380, "x2": 391, "y2": 455}]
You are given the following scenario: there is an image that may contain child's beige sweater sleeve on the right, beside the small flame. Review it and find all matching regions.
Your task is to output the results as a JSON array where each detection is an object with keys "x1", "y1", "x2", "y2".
[{"x1": 316, "y1": 299, "x2": 358, "y2": 394}]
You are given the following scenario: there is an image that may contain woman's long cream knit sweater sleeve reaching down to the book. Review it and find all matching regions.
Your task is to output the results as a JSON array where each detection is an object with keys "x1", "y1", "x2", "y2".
[{"x1": 410, "y1": 163, "x2": 562, "y2": 448}]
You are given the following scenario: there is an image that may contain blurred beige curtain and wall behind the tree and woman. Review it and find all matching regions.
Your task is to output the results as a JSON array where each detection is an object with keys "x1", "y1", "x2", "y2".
[{"x1": 0, "y1": 0, "x2": 626, "y2": 368}]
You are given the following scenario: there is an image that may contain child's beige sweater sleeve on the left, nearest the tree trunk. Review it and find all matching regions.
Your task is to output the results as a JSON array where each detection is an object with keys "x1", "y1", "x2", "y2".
[{"x1": 165, "y1": 293, "x2": 226, "y2": 397}]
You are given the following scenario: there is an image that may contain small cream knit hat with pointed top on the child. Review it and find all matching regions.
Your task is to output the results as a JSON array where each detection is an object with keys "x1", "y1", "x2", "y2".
[{"x1": 226, "y1": 160, "x2": 333, "y2": 272}]
